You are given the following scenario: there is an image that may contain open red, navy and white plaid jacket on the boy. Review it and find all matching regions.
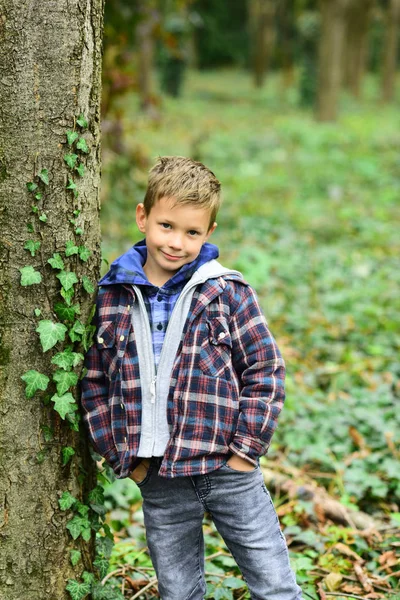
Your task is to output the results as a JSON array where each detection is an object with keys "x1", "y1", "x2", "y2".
[{"x1": 81, "y1": 276, "x2": 285, "y2": 478}]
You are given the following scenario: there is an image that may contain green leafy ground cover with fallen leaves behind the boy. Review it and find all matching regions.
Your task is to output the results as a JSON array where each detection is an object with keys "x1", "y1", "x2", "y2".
[{"x1": 97, "y1": 71, "x2": 400, "y2": 600}]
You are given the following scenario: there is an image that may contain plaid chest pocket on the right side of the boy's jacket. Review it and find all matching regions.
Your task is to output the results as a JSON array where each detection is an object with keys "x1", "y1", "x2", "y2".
[{"x1": 199, "y1": 317, "x2": 232, "y2": 380}]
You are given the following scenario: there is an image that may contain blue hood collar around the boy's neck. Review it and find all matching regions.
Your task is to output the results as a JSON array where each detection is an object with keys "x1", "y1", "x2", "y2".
[{"x1": 99, "y1": 240, "x2": 219, "y2": 289}]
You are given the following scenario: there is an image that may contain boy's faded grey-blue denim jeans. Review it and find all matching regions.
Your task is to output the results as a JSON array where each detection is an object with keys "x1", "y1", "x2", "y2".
[{"x1": 138, "y1": 459, "x2": 301, "y2": 600}]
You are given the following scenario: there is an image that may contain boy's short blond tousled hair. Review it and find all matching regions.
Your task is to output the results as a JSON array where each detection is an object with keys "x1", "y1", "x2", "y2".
[{"x1": 143, "y1": 156, "x2": 221, "y2": 228}]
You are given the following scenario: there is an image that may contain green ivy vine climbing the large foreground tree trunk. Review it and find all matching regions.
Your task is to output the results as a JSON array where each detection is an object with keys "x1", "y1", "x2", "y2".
[{"x1": 20, "y1": 115, "x2": 119, "y2": 600}]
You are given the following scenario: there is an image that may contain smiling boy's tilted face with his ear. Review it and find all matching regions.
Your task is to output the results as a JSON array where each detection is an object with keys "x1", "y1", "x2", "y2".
[{"x1": 136, "y1": 197, "x2": 217, "y2": 287}]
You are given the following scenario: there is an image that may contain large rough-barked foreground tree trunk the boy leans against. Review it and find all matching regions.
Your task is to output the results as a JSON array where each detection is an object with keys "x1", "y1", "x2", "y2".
[{"x1": 0, "y1": 0, "x2": 103, "y2": 600}]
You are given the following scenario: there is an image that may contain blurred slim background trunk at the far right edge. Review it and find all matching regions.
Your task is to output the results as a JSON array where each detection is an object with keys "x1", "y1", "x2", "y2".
[{"x1": 382, "y1": 0, "x2": 400, "y2": 102}]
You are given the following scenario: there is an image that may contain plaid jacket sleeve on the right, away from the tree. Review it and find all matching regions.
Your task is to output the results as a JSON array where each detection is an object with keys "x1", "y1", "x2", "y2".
[{"x1": 229, "y1": 285, "x2": 285, "y2": 464}]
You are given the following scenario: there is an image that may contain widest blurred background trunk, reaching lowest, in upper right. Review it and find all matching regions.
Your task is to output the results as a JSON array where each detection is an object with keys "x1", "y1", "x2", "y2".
[{"x1": 317, "y1": 0, "x2": 350, "y2": 121}]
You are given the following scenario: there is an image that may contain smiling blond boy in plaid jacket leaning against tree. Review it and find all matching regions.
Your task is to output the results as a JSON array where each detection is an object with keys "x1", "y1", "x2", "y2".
[{"x1": 82, "y1": 157, "x2": 301, "y2": 600}]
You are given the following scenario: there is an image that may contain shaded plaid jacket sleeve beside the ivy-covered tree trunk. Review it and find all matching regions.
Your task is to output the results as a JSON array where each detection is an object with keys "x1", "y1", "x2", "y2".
[{"x1": 81, "y1": 304, "x2": 121, "y2": 474}]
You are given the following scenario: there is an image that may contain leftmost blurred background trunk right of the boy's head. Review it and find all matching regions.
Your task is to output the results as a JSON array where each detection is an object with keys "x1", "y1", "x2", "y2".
[{"x1": 249, "y1": 0, "x2": 275, "y2": 88}]
